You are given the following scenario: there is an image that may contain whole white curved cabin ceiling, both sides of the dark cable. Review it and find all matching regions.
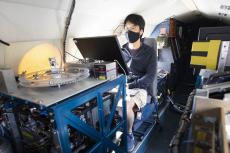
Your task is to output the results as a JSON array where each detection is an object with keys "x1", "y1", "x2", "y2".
[{"x1": 0, "y1": 0, "x2": 230, "y2": 42}]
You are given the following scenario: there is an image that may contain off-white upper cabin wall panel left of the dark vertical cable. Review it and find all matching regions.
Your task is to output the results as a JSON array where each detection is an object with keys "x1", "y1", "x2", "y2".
[{"x1": 0, "y1": 0, "x2": 68, "y2": 42}]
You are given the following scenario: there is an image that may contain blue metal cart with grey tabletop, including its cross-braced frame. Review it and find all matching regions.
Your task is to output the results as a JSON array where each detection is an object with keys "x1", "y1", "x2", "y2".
[{"x1": 0, "y1": 75, "x2": 127, "y2": 153}]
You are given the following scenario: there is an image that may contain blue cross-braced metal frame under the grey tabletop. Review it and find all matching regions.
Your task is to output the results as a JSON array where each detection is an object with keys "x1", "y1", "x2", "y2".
[{"x1": 0, "y1": 75, "x2": 127, "y2": 153}]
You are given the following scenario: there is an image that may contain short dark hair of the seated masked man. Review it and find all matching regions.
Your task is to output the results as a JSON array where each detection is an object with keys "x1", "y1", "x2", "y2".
[{"x1": 124, "y1": 14, "x2": 145, "y2": 31}]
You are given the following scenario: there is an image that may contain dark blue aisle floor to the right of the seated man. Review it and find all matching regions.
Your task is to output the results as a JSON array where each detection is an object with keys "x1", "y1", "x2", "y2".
[{"x1": 145, "y1": 85, "x2": 192, "y2": 153}]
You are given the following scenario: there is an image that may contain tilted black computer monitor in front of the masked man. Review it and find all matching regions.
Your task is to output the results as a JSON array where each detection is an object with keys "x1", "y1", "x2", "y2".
[{"x1": 73, "y1": 36, "x2": 128, "y2": 74}]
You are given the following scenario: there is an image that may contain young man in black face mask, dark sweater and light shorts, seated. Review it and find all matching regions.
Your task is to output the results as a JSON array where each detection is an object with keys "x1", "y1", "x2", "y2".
[{"x1": 122, "y1": 14, "x2": 157, "y2": 152}]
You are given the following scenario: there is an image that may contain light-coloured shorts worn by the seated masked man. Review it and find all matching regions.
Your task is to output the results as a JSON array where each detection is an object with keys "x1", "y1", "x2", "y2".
[{"x1": 126, "y1": 88, "x2": 147, "y2": 110}]
